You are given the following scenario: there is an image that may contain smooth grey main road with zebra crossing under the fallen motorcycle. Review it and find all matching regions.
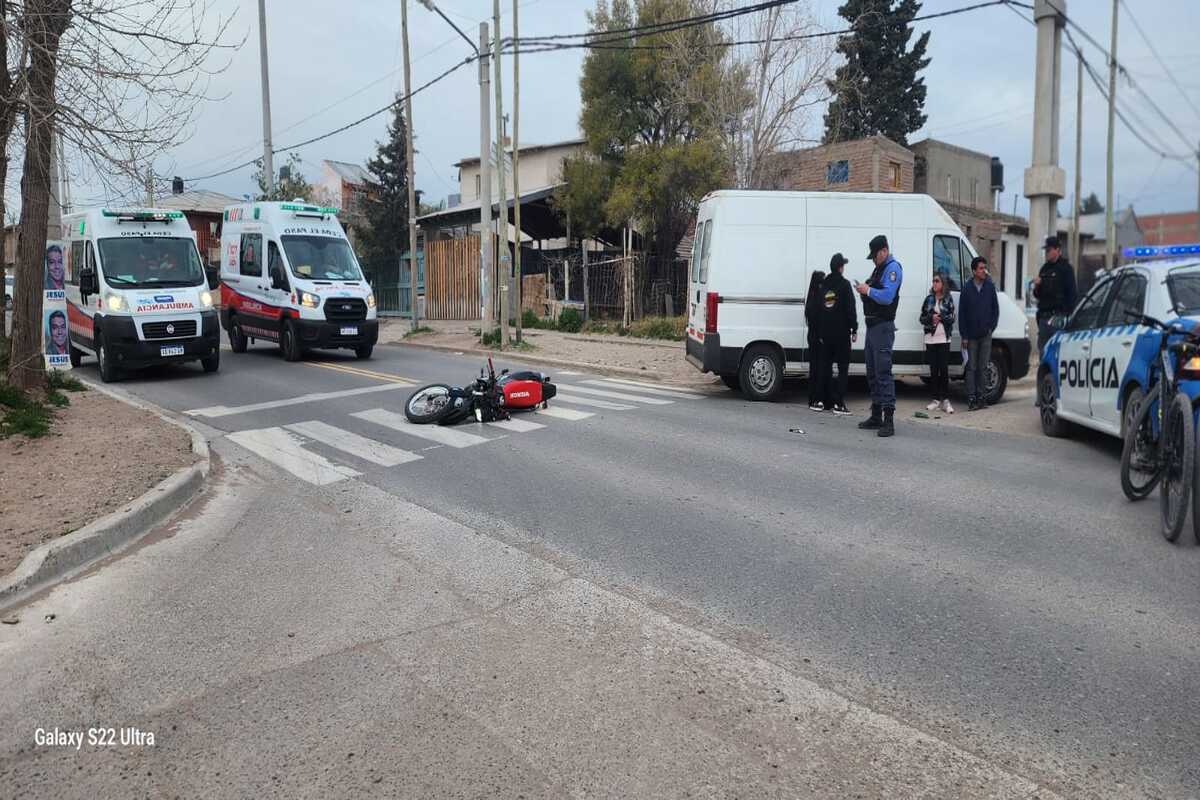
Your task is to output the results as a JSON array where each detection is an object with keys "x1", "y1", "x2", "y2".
[{"x1": 0, "y1": 347, "x2": 1200, "y2": 798}]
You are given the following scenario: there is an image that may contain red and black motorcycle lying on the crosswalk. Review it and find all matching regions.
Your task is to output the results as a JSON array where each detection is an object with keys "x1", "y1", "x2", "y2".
[{"x1": 404, "y1": 359, "x2": 558, "y2": 425}]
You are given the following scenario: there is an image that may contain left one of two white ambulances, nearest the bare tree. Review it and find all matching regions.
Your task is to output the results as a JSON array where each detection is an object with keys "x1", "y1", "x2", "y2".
[{"x1": 62, "y1": 209, "x2": 221, "y2": 381}]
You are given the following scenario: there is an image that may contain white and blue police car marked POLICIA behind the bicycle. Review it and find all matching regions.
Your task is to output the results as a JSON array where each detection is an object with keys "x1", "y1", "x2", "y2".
[{"x1": 1038, "y1": 245, "x2": 1200, "y2": 437}]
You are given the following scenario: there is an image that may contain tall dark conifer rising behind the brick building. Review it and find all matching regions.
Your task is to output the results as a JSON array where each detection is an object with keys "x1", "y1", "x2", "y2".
[{"x1": 824, "y1": 0, "x2": 929, "y2": 144}]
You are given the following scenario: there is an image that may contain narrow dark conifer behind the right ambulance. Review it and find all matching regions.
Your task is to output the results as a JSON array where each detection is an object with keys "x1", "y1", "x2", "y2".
[{"x1": 360, "y1": 103, "x2": 420, "y2": 281}]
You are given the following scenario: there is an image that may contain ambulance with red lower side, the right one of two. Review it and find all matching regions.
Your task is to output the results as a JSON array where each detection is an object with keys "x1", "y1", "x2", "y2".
[{"x1": 221, "y1": 200, "x2": 379, "y2": 361}]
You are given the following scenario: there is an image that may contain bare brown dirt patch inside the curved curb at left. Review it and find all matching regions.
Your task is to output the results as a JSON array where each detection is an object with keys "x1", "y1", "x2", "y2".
[{"x1": 0, "y1": 391, "x2": 196, "y2": 576}]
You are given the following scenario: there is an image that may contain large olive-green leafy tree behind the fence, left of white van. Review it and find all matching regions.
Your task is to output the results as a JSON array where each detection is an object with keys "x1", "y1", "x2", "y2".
[{"x1": 556, "y1": 0, "x2": 732, "y2": 253}]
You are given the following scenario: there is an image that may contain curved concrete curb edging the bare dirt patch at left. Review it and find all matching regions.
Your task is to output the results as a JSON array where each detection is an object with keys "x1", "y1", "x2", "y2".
[{"x1": 0, "y1": 381, "x2": 211, "y2": 608}]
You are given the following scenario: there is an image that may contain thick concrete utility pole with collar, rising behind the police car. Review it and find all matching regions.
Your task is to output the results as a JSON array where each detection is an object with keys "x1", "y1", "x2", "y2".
[{"x1": 1025, "y1": 0, "x2": 1067, "y2": 272}]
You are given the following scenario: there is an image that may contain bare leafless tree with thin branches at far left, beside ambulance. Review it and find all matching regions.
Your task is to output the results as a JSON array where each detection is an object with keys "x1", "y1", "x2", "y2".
[{"x1": 0, "y1": 0, "x2": 245, "y2": 387}]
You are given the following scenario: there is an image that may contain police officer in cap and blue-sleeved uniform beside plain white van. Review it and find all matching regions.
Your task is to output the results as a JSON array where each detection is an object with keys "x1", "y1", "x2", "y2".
[{"x1": 854, "y1": 235, "x2": 904, "y2": 437}]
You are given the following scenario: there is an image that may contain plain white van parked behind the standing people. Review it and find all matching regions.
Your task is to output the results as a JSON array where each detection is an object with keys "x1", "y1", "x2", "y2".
[{"x1": 686, "y1": 191, "x2": 1031, "y2": 402}]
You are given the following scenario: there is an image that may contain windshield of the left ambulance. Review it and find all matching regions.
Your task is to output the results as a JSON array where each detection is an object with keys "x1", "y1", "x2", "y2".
[{"x1": 100, "y1": 236, "x2": 205, "y2": 289}]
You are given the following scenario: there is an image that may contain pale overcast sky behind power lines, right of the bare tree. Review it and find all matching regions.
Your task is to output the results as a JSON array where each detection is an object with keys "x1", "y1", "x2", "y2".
[{"x1": 74, "y1": 0, "x2": 1200, "y2": 221}]
